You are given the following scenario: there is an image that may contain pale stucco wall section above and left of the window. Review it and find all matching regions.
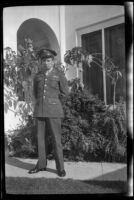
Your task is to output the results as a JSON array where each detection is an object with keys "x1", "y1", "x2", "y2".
[{"x1": 65, "y1": 5, "x2": 124, "y2": 79}]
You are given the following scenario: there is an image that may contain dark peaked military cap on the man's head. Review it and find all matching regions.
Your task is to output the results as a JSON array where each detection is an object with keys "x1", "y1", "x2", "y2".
[{"x1": 37, "y1": 48, "x2": 57, "y2": 59}]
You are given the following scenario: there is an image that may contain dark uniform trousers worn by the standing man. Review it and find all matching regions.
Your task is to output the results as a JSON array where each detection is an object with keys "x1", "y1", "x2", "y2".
[{"x1": 37, "y1": 117, "x2": 64, "y2": 171}]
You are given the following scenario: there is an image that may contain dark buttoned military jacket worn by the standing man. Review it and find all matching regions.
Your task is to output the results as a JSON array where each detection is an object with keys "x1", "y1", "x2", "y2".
[{"x1": 33, "y1": 67, "x2": 68, "y2": 118}]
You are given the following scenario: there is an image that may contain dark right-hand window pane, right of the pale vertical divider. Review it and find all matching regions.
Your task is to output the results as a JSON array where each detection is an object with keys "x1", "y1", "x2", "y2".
[{"x1": 104, "y1": 24, "x2": 126, "y2": 103}]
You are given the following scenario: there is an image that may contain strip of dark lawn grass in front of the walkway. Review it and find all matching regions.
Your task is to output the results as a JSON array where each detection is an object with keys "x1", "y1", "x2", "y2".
[{"x1": 6, "y1": 177, "x2": 127, "y2": 194}]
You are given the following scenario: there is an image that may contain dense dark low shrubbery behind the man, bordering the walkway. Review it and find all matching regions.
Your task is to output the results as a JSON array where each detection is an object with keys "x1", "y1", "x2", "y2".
[{"x1": 7, "y1": 79, "x2": 127, "y2": 162}]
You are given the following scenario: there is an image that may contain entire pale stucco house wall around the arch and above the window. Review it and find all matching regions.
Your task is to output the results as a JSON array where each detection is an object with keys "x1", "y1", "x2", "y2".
[{"x1": 3, "y1": 5, "x2": 124, "y2": 133}]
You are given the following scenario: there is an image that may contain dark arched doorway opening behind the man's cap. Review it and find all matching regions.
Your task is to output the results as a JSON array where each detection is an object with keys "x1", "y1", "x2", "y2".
[{"x1": 17, "y1": 18, "x2": 60, "y2": 61}]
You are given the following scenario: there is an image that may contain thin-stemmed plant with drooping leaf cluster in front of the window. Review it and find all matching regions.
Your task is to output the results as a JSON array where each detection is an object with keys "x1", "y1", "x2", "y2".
[{"x1": 64, "y1": 47, "x2": 122, "y2": 107}]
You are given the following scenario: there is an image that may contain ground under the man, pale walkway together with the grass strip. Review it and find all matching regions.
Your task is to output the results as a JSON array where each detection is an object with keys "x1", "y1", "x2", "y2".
[{"x1": 5, "y1": 151, "x2": 127, "y2": 194}]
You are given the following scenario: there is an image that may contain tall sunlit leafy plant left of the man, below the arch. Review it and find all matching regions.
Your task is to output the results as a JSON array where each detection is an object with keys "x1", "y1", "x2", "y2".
[{"x1": 3, "y1": 38, "x2": 39, "y2": 123}]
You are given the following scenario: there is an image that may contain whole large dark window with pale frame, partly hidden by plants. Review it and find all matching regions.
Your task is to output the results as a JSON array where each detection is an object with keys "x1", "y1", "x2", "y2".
[{"x1": 77, "y1": 16, "x2": 126, "y2": 104}]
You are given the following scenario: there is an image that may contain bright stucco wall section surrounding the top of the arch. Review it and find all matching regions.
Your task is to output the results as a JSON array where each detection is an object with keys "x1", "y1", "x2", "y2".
[{"x1": 3, "y1": 6, "x2": 60, "y2": 51}]
